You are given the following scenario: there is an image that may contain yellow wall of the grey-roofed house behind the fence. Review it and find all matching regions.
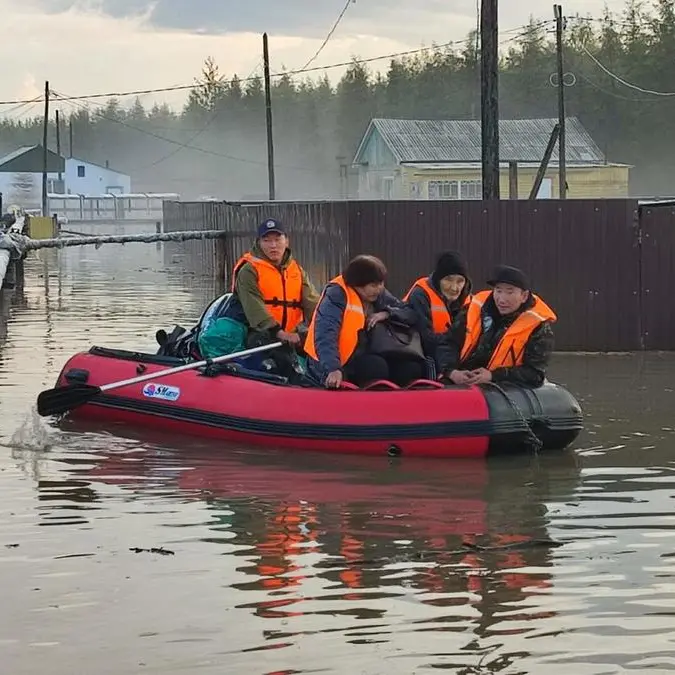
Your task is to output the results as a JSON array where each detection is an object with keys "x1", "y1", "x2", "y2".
[{"x1": 401, "y1": 165, "x2": 630, "y2": 199}]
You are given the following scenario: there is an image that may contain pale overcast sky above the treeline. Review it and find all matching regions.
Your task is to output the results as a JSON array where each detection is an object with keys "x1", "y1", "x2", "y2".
[{"x1": 0, "y1": 0, "x2": 624, "y2": 115}]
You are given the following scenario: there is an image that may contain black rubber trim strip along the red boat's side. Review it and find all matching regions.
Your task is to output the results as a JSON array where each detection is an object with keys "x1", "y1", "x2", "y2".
[{"x1": 90, "y1": 394, "x2": 525, "y2": 441}]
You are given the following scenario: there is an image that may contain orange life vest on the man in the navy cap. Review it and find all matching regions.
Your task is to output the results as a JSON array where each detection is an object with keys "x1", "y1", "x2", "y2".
[{"x1": 232, "y1": 253, "x2": 304, "y2": 332}]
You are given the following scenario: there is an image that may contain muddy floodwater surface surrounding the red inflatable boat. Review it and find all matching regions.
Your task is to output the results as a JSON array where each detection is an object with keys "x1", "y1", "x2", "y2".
[{"x1": 0, "y1": 230, "x2": 675, "y2": 675}]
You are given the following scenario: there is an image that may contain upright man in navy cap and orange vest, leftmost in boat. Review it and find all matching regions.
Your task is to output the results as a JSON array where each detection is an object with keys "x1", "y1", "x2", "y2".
[{"x1": 228, "y1": 218, "x2": 319, "y2": 360}]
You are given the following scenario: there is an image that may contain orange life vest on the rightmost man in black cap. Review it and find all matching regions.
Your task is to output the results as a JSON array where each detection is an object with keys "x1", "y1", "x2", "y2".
[{"x1": 459, "y1": 291, "x2": 558, "y2": 370}]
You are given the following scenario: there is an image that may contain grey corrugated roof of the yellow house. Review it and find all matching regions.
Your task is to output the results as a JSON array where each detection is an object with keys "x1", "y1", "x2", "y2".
[{"x1": 354, "y1": 117, "x2": 605, "y2": 164}]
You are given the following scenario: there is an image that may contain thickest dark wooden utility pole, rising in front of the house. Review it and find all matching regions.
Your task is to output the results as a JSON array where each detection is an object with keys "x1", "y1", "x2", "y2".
[{"x1": 480, "y1": 0, "x2": 499, "y2": 200}]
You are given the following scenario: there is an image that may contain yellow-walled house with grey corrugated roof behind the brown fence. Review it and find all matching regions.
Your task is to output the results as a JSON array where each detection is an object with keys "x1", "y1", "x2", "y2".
[{"x1": 352, "y1": 117, "x2": 631, "y2": 199}]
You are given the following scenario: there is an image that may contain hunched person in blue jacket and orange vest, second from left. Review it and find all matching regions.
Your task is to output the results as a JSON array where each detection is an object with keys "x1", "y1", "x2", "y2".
[{"x1": 305, "y1": 255, "x2": 426, "y2": 389}]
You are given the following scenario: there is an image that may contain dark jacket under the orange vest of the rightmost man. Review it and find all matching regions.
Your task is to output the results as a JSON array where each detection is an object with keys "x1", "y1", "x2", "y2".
[{"x1": 436, "y1": 296, "x2": 554, "y2": 387}]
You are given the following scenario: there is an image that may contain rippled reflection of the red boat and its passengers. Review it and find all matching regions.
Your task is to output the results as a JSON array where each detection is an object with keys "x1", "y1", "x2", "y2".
[{"x1": 41, "y1": 428, "x2": 579, "y2": 667}]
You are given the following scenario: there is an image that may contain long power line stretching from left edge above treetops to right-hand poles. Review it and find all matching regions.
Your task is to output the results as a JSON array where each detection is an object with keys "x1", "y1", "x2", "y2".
[{"x1": 0, "y1": 21, "x2": 540, "y2": 105}]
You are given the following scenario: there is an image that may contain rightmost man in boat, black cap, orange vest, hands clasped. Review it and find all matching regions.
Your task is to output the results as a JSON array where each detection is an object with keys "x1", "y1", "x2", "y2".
[{"x1": 437, "y1": 265, "x2": 557, "y2": 387}]
